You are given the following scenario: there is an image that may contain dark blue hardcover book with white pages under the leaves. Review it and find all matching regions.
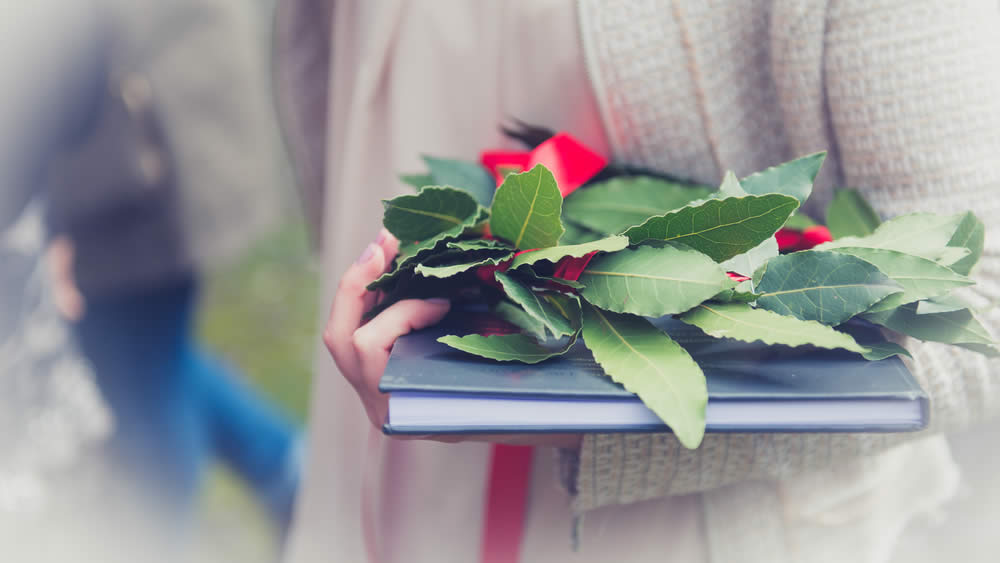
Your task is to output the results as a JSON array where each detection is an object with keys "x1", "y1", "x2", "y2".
[{"x1": 379, "y1": 312, "x2": 929, "y2": 434}]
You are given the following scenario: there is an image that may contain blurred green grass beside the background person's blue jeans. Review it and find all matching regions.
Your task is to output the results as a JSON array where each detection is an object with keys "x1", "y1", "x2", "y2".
[{"x1": 195, "y1": 219, "x2": 319, "y2": 563}]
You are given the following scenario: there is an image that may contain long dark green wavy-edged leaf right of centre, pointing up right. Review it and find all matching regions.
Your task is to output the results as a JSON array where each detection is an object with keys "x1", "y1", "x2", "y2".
[{"x1": 625, "y1": 194, "x2": 799, "y2": 262}]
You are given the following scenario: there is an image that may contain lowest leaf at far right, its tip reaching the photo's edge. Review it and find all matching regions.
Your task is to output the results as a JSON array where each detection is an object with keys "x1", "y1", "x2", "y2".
[{"x1": 864, "y1": 303, "x2": 996, "y2": 353}]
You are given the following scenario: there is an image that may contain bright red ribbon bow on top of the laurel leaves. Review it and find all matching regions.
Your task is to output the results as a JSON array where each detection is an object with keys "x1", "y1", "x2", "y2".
[{"x1": 479, "y1": 133, "x2": 608, "y2": 197}]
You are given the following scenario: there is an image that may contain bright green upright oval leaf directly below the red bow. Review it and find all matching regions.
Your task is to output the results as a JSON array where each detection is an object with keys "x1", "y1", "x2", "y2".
[{"x1": 490, "y1": 164, "x2": 564, "y2": 250}]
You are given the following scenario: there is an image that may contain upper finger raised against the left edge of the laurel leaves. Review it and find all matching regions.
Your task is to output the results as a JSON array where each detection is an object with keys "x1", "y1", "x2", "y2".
[{"x1": 323, "y1": 243, "x2": 388, "y2": 376}]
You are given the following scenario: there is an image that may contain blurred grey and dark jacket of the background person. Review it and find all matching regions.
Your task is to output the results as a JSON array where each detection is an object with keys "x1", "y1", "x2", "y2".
[{"x1": 48, "y1": 0, "x2": 284, "y2": 295}]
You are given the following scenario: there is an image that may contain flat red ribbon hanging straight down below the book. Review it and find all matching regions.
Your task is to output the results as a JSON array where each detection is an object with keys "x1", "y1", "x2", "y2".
[{"x1": 479, "y1": 444, "x2": 534, "y2": 563}]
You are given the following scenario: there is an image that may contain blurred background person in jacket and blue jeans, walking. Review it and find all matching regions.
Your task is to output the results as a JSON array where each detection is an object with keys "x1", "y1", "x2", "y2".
[{"x1": 46, "y1": 0, "x2": 300, "y2": 555}]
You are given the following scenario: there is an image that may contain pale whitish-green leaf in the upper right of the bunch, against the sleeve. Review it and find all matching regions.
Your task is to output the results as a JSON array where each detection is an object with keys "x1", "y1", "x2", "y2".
[{"x1": 816, "y1": 213, "x2": 966, "y2": 264}]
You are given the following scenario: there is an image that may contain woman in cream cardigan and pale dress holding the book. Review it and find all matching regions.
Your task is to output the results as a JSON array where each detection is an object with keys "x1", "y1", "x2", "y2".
[{"x1": 275, "y1": 0, "x2": 1000, "y2": 563}]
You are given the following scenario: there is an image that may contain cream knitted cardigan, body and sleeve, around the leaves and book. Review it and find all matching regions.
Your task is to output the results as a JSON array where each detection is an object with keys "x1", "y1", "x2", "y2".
[{"x1": 564, "y1": 0, "x2": 1000, "y2": 511}]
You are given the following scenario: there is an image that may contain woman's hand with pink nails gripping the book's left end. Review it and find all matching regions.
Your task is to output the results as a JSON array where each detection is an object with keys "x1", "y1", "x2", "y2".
[{"x1": 323, "y1": 229, "x2": 581, "y2": 447}]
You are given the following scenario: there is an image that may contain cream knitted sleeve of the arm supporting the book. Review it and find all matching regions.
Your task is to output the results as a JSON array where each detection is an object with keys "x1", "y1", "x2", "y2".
[{"x1": 561, "y1": 0, "x2": 1000, "y2": 511}]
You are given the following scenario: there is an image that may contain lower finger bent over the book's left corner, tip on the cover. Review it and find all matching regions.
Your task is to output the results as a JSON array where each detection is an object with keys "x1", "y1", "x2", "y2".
[{"x1": 352, "y1": 299, "x2": 451, "y2": 427}]
